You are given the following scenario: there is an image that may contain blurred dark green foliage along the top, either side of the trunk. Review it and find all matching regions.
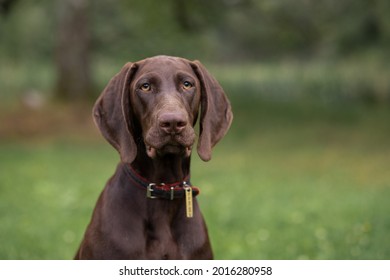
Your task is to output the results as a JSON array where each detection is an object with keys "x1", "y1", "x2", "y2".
[{"x1": 0, "y1": 0, "x2": 390, "y2": 61}]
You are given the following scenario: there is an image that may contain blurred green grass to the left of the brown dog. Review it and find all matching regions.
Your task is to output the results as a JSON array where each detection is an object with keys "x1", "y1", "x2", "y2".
[{"x1": 0, "y1": 142, "x2": 115, "y2": 259}]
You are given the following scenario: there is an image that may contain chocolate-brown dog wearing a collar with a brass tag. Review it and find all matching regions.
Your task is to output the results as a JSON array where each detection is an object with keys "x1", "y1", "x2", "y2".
[{"x1": 75, "y1": 56, "x2": 233, "y2": 259}]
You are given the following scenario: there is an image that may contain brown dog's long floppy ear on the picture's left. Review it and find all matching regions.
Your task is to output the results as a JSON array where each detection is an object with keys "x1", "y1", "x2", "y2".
[{"x1": 93, "y1": 62, "x2": 137, "y2": 163}]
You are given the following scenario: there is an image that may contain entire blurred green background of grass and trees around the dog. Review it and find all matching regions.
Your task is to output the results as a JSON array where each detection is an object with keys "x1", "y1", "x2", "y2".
[{"x1": 0, "y1": 0, "x2": 390, "y2": 259}]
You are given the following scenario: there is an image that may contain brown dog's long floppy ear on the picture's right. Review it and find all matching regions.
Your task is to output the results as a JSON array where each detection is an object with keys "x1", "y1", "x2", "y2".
[{"x1": 191, "y1": 61, "x2": 233, "y2": 161}]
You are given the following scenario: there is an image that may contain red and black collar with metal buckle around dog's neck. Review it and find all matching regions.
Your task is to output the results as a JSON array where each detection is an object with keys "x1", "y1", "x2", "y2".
[{"x1": 126, "y1": 164, "x2": 200, "y2": 200}]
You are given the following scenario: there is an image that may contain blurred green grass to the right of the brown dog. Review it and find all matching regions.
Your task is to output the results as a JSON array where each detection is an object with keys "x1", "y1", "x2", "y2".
[{"x1": 204, "y1": 99, "x2": 390, "y2": 259}]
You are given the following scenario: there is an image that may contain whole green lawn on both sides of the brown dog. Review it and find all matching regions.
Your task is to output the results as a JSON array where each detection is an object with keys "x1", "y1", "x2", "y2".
[{"x1": 0, "y1": 60, "x2": 390, "y2": 259}]
